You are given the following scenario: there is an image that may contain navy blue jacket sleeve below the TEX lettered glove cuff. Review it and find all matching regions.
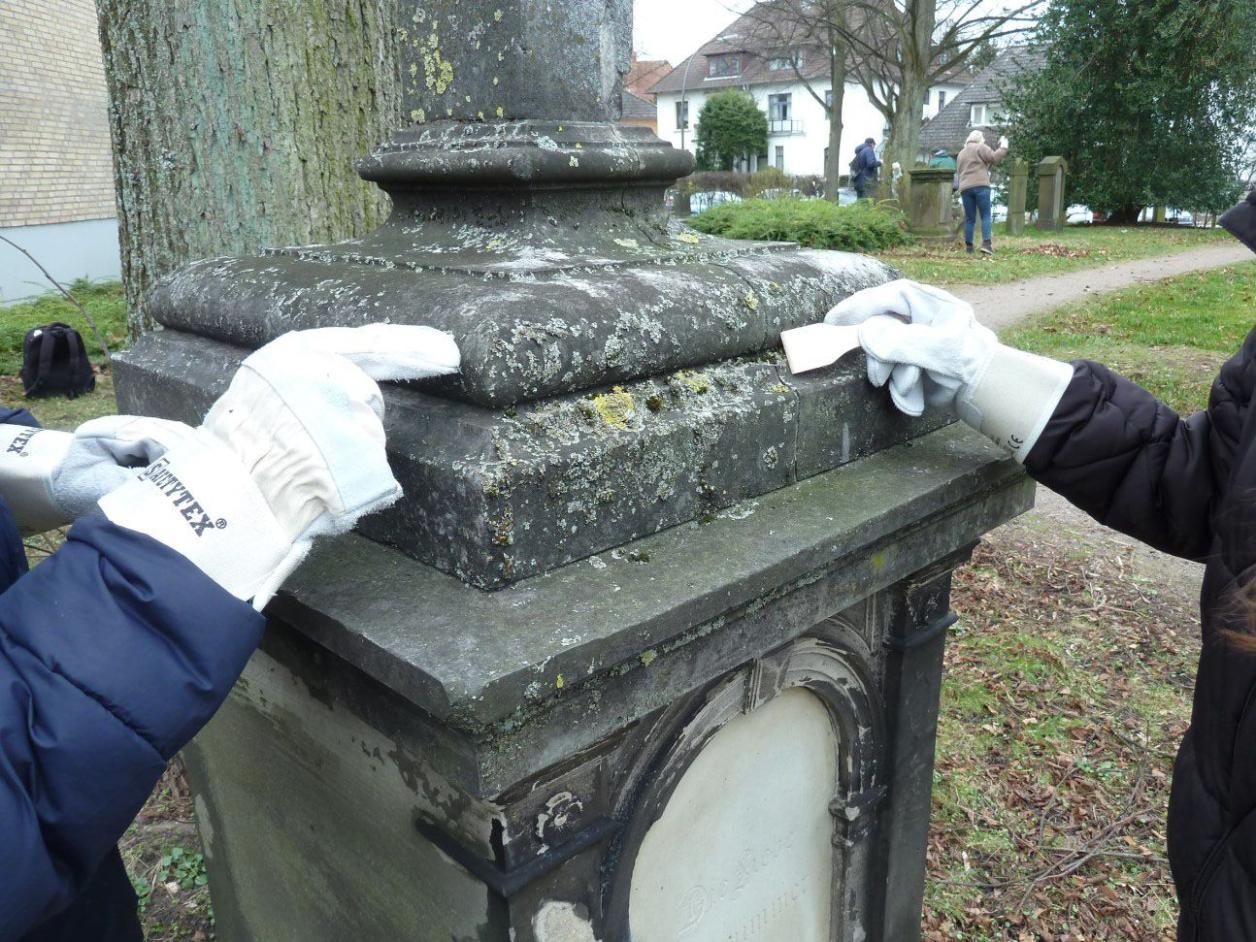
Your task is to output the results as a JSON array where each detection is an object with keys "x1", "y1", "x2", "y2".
[{"x1": 0, "y1": 519, "x2": 264, "y2": 939}]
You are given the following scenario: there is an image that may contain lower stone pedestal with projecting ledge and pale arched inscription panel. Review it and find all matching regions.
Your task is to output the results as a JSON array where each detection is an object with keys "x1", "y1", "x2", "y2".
[{"x1": 187, "y1": 427, "x2": 1032, "y2": 942}]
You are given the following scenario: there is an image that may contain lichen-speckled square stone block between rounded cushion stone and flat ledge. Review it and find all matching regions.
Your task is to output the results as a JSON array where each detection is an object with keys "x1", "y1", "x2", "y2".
[{"x1": 117, "y1": 330, "x2": 948, "y2": 588}]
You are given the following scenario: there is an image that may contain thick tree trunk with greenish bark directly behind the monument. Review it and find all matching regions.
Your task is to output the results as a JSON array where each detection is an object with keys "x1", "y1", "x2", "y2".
[{"x1": 97, "y1": 0, "x2": 401, "y2": 334}]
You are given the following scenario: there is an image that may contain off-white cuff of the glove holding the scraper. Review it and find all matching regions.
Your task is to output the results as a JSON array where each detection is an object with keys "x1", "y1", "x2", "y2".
[{"x1": 956, "y1": 344, "x2": 1073, "y2": 462}]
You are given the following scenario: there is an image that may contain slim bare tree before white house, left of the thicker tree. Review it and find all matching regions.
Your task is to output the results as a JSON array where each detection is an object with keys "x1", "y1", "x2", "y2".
[{"x1": 741, "y1": 0, "x2": 852, "y2": 200}]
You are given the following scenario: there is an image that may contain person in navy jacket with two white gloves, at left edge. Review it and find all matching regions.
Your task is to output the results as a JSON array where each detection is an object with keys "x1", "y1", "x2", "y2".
[{"x1": 0, "y1": 325, "x2": 458, "y2": 942}]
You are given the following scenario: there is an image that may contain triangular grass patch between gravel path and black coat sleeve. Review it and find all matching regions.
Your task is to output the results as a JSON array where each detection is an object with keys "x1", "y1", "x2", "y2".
[{"x1": 1002, "y1": 263, "x2": 1256, "y2": 412}]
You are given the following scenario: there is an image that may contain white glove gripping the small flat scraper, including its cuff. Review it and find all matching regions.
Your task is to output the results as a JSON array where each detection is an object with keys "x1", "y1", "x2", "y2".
[{"x1": 824, "y1": 279, "x2": 1073, "y2": 461}]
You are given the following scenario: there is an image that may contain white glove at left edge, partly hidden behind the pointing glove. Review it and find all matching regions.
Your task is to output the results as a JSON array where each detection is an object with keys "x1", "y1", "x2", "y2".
[{"x1": 0, "y1": 416, "x2": 192, "y2": 533}]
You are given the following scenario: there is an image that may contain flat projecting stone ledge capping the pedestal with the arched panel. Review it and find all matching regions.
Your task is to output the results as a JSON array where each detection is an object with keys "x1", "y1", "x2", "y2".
[{"x1": 259, "y1": 426, "x2": 1032, "y2": 748}]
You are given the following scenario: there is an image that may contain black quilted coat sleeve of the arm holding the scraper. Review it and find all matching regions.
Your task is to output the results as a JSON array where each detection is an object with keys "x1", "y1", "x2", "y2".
[{"x1": 1025, "y1": 354, "x2": 1252, "y2": 560}]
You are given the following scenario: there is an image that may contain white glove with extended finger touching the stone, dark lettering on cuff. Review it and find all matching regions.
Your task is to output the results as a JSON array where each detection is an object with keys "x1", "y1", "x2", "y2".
[{"x1": 100, "y1": 324, "x2": 460, "y2": 610}]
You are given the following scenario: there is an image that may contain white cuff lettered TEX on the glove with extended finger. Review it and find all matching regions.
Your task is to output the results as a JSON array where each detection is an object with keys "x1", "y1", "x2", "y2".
[{"x1": 100, "y1": 428, "x2": 293, "y2": 608}]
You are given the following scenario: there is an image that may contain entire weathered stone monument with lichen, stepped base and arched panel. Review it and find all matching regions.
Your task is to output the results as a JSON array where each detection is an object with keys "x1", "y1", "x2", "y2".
[{"x1": 117, "y1": 0, "x2": 1032, "y2": 942}]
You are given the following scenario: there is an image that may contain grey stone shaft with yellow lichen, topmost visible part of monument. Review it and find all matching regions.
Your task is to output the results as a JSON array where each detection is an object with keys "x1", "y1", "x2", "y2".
[{"x1": 399, "y1": 0, "x2": 632, "y2": 123}]
